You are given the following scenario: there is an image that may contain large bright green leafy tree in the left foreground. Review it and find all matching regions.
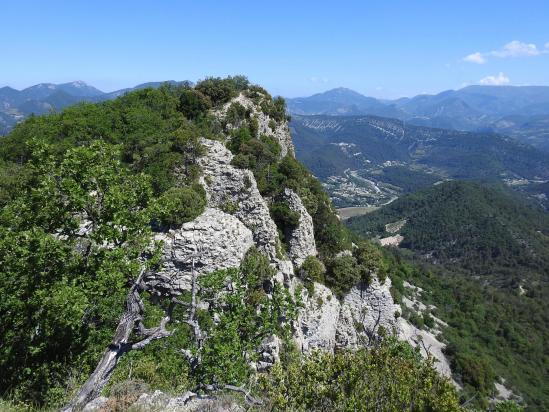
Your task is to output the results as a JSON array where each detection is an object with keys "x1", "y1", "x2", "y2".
[{"x1": 0, "y1": 142, "x2": 158, "y2": 403}]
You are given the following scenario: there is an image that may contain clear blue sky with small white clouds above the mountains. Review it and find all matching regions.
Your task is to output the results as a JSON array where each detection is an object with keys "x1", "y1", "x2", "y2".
[{"x1": 0, "y1": 0, "x2": 549, "y2": 98}]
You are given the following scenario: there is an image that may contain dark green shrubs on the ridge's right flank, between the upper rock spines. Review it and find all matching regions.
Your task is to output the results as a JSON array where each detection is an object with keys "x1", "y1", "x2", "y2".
[{"x1": 227, "y1": 102, "x2": 351, "y2": 260}]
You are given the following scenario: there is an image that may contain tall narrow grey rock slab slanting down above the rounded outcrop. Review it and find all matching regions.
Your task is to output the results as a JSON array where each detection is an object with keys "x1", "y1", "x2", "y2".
[{"x1": 200, "y1": 139, "x2": 293, "y2": 280}]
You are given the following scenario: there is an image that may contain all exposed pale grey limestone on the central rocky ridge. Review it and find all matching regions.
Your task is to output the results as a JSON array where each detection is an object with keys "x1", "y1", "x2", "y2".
[{"x1": 147, "y1": 94, "x2": 449, "y2": 384}]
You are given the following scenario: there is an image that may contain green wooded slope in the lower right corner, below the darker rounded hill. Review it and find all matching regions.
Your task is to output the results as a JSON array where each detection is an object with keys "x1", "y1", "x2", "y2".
[{"x1": 385, "y1": 251, "x2": 549, "y2": 411}]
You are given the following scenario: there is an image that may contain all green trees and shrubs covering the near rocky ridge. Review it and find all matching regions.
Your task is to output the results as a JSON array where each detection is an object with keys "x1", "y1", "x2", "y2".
[{"x1": 0, "y1": 76, "x2": 528, "y2": 411}]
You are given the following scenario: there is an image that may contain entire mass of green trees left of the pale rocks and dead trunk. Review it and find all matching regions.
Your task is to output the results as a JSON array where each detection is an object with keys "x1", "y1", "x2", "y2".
[{"x1": 0, "y1": 78, "x2": 248, "y2": 405}]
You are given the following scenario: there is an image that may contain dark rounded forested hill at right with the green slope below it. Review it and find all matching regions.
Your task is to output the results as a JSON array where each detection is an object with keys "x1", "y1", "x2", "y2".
[{"x1": 347, "y1": 181, "x2": 549, "y2": 410}]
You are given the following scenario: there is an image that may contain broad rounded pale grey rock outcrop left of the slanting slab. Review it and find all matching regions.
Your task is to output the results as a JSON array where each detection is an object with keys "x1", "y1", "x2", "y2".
[{"x1": 147, "y1": 208, "x2": 254, "y2": 294}]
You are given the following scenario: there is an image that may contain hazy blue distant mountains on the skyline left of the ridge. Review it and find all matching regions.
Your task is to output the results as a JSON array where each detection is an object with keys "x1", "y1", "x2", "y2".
[{"x1": 0, "y1": 80, "x2": 186, "y2": 135}]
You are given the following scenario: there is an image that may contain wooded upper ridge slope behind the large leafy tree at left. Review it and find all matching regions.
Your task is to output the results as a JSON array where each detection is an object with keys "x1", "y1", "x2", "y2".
[{"x1": 0, "y1": 84, "x2": 212, "y2": 194}]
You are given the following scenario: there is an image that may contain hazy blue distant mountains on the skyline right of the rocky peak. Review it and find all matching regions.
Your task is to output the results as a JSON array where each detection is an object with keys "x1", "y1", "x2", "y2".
[{"x1": 286, "y1": 86, "x2": 549, "y2": 151}]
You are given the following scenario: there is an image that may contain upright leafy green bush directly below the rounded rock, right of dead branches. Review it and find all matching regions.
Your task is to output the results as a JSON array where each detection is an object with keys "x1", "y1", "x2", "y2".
[{"x1": 197, "y1": 249, "x2": 296, "y2": 385}]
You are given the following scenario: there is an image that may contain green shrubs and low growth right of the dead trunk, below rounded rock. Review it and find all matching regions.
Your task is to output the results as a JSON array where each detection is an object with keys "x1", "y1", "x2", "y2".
[{"x1": 111, "y1": 249, "x2": 296, "y2": 395}]
